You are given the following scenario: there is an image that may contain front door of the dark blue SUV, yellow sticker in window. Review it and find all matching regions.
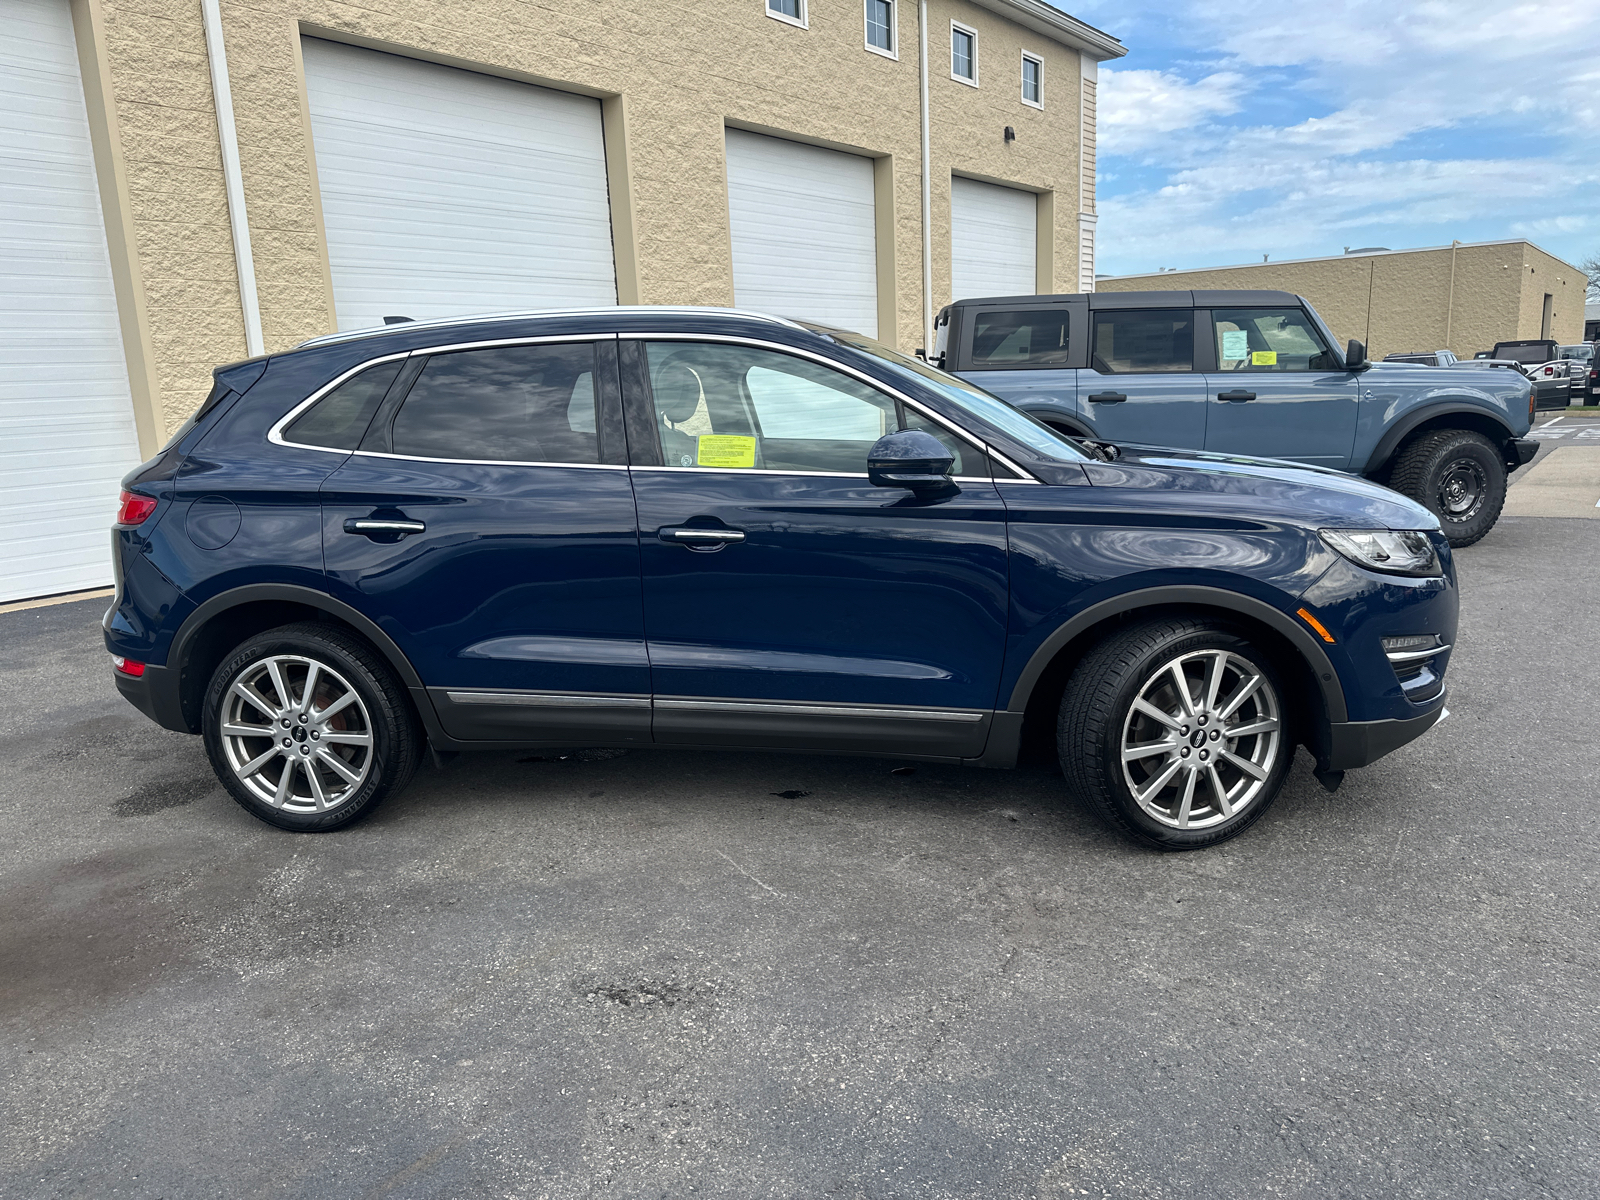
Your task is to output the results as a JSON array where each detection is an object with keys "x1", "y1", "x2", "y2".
[{"x1": 621, "y1": 338, "x2": 1006, "y2": 758}]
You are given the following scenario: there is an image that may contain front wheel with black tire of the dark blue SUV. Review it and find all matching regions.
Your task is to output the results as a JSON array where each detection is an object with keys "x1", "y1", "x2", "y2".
[{"x1": 1056, "y1": 618, "x2": 1294, "y2": 850}]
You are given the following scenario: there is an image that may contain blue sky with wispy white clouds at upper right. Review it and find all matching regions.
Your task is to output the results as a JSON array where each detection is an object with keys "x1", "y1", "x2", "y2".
[{"x1": 1056, "y1": 0, "x2": 1600, "y2": 274}]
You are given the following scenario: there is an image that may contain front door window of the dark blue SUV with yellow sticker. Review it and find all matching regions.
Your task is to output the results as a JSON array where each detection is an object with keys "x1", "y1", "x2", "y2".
[{"x1": 646, "y1": 342, "x2": 987, "y2": 475}]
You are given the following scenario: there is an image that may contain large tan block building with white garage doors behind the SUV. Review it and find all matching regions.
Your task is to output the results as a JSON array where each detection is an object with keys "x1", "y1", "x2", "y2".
[{"x1": 0, "y1": 0, "x2": 1125, "y2": 602}]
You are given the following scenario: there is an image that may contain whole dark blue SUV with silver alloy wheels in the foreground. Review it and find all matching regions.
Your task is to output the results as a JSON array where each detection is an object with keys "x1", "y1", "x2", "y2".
[{"x1": 104, "y1": 307, "x2": 1456, "y2": 848}]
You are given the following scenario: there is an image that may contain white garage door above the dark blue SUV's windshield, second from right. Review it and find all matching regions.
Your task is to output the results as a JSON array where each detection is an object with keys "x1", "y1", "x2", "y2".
[{"x1": 728, "y1": 130, "x2": 878, "y2": 338}]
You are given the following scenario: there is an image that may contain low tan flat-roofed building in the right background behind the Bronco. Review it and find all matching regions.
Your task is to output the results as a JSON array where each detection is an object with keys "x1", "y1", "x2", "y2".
[{"x1": 1098, "y1": 240, "x2": 1587, "y2": 358}]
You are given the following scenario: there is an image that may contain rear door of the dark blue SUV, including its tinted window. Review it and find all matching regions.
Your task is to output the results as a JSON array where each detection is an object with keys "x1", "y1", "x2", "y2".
[{"x1": 322, "y1": 336, "x2": 650, "y2": 742}]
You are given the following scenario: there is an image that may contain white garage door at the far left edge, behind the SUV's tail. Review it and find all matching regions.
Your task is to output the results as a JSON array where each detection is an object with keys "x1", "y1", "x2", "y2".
[{"x1": 0, "y1": 0, "x2": 139, "y2": 600}]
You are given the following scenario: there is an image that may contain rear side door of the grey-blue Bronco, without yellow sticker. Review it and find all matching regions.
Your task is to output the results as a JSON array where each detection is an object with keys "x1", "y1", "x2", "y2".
[{"x1": 1078, "y1": 309, "x2": 1206, "y2": 450}]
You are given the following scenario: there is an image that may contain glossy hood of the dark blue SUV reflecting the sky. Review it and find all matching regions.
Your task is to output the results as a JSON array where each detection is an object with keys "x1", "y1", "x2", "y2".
[{"x1": 1083, "y1": 443, "x2": 1438, "y2": 530}]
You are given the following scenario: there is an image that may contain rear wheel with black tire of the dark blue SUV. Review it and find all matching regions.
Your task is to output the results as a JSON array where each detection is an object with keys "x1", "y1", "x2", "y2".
[{"x1": 202, "y1": 621, "x2": 424, "y2": 834}]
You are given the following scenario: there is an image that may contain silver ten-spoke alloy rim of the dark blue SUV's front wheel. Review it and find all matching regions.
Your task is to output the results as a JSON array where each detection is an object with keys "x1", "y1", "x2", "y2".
[{"x1": 1122, "y1": 650, "x2": 1283, "y2": 829}]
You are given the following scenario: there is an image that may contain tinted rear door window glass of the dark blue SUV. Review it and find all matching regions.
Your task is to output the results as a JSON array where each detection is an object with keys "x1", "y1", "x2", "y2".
[{"x1": 392, "y1": 342, "x2": 600, "y2": 462}]
